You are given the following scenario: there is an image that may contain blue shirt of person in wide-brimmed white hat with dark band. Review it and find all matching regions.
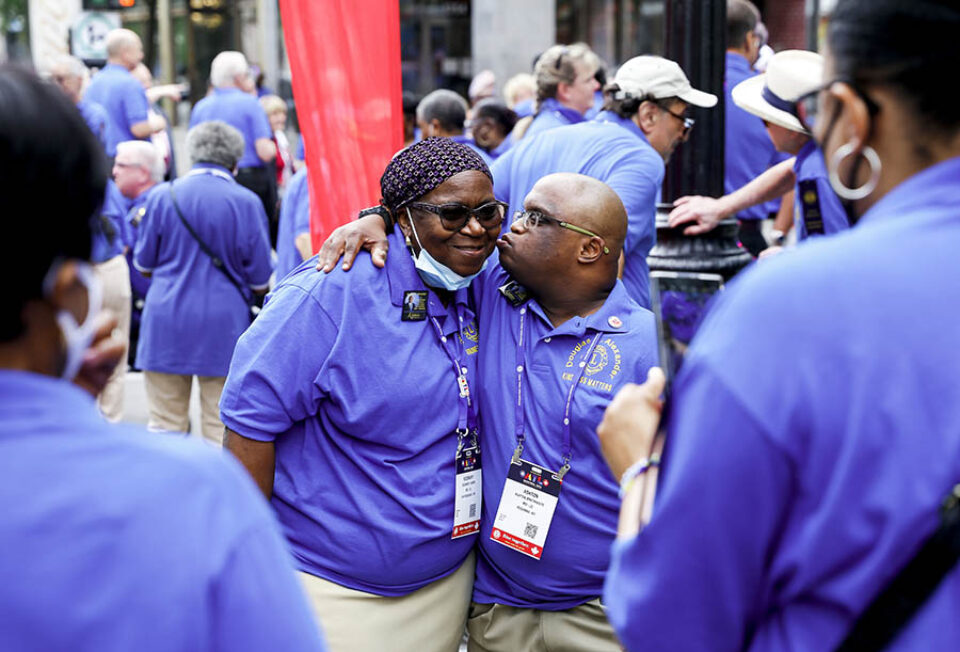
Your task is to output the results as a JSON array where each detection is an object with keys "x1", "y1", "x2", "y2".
[{"x1": 793, "y1": 140, "x2": 850, "y2": 240}]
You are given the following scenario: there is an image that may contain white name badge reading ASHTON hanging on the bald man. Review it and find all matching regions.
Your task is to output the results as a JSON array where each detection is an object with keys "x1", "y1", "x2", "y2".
[{"x1": 490, "y1": 460, "x2": 563, "y2": 559}]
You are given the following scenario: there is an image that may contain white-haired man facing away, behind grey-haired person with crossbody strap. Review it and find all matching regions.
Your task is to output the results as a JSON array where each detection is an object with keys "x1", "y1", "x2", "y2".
[{"x1": 190, "y1": 50, "x2": 277, "y2": 240}]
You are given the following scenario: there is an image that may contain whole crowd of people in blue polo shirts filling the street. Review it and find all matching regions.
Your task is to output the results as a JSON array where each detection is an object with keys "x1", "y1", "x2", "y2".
[{"x1": 0, "y1": 0, "x2": 960, "y2": 652}]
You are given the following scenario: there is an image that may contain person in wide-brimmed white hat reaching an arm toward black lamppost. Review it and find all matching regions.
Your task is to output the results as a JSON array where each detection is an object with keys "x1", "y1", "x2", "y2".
[{"x1": 670, "y1": 50, "x2": 850, "y2": 258}]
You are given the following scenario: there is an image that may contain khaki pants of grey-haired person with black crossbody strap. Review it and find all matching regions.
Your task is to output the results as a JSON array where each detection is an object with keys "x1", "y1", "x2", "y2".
[{"x1": 143, "y1": 371, "x2": 227, "y2": 446}]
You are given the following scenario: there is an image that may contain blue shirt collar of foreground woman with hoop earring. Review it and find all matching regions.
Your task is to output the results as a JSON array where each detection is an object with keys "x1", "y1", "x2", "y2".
[{"x1": 857, "y1": 156, "x2": 960, "y2": 228}]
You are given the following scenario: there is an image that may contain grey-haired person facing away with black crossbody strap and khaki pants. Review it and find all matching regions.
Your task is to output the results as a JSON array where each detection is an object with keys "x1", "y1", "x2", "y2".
[{"x1": 133, "y1": 119, "x2": 273, "y2": 445}]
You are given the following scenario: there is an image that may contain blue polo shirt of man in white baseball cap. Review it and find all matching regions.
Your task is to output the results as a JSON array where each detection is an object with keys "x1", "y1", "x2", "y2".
[{"x1": 490, "y1": 111, "x2": 664, "y2": 308}]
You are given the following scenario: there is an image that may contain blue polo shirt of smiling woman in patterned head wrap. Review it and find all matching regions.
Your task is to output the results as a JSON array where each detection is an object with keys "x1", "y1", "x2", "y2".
[{"x1": 220, "y1": 233, "x2": 478, "y2": 596}]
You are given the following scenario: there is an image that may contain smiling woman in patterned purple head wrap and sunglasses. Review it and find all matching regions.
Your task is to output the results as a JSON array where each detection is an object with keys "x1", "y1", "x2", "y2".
[{"x1": 221, "y1": 138, "x2": 504, "y2": 652}]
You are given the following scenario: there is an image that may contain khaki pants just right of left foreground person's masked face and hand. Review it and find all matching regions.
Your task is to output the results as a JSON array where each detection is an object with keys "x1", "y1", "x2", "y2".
[{"x1": 93, "y1": 256, "x2": 132, "y2": 422}]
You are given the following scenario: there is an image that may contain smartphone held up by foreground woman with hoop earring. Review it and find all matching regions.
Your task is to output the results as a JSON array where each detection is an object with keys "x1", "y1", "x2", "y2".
[{"x1": 650, "y1": 272, "x2": 723, "y2": 398}]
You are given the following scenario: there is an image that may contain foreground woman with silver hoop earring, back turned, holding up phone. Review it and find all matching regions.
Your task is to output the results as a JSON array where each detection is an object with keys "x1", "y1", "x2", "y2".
[{"x1": 599, "y1": 0, "x2": 960, "y2": 650}]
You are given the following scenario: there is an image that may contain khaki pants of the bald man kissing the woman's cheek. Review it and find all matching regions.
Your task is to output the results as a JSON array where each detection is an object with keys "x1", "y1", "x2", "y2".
[{"x1": 467, "y1": 599, "x2": 623, "y2": 652}]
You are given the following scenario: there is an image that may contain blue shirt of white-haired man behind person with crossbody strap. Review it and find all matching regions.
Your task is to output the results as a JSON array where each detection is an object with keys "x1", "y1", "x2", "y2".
[{"x1": 190, "y1": 88, "x2": 273, "y2": 168}]
